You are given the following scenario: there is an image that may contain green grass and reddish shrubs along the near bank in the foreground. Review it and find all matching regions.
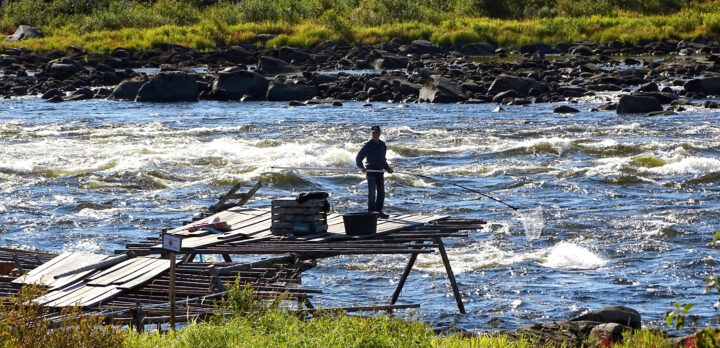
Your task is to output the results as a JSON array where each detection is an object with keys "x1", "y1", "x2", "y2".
[{"x1": 0, "y1": 281, "x2": 696, "y2": 348}]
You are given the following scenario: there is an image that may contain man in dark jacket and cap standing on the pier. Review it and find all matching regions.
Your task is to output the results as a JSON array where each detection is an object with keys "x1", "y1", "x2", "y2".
[{"x1": 355, "y1": 126, "x2": 393, "y2": 219}]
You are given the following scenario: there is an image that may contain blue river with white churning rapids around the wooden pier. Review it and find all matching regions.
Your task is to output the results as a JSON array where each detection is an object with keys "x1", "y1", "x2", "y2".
[{"x1": 0, "y1": 96, "x2": 720, "y2": 332}]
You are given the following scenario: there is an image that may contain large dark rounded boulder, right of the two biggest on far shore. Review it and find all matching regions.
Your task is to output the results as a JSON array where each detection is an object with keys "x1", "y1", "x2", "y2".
[{"x1": 211, "y1": 69, "x2": 269, "y2": 100}]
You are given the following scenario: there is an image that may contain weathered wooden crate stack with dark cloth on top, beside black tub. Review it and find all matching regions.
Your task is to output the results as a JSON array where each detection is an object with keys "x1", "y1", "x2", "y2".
[{"x1": 270, "y1": 198, "x2": 329, "y2": 236}]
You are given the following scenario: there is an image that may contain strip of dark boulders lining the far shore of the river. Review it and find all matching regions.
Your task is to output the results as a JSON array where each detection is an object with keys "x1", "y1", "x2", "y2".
[{"x1": 0, "y1": 38, "x2": 720, "y2": 114}]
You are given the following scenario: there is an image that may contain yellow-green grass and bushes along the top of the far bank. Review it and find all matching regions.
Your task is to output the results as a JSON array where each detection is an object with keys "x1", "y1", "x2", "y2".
[{"x1": 0, "y1": 0, "x2": 720, "y2": 51}]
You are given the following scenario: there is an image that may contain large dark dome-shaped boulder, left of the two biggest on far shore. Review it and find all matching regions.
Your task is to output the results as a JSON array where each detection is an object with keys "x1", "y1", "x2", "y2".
[{"x1": 135, "y1": 71, "x2": 200, "y2": 103}]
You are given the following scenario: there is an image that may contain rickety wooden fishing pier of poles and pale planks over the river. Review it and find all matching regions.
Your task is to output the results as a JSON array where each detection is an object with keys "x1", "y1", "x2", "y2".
[{"x1": 0, "y1": 185, "x2": 485, "y2": 330}]
